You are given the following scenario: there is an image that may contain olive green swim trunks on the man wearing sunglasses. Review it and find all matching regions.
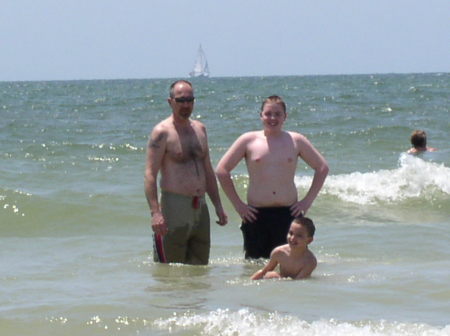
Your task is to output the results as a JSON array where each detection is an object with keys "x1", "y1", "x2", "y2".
[{"x1": 153, "y1": 191, "x2": 211, "y2": 265}]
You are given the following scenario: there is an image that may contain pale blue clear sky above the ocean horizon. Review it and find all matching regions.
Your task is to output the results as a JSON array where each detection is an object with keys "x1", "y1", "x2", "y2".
[{"x1": 0, "y1": 0, "x2": 450, "y2": 81}]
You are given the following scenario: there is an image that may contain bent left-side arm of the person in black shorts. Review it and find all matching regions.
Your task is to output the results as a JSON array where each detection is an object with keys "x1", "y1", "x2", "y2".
[{"x1": 216, "y1": 134, "x2": 256, "y2": 222}]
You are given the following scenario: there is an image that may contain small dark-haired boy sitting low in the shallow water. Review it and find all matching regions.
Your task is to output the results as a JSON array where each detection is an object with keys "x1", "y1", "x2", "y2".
[{"x1": 251, "y1": 217, "x2": 317, "y2": 280}]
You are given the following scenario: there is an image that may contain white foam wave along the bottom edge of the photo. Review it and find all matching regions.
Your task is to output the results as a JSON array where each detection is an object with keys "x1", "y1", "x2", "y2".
[{"x1": 153, "y1": 309, "x2": 450, "y2": 336}]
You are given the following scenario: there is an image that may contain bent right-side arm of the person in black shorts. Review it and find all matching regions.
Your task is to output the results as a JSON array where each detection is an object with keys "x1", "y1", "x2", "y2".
[{"x1": 291, "y1": 134, "x2": 329, "y2": 216}]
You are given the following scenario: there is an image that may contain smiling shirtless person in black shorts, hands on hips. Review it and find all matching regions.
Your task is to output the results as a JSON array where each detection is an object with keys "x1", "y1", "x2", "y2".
[{"x1": 216, "y1": 96, "x2": 328, "y2": 259}]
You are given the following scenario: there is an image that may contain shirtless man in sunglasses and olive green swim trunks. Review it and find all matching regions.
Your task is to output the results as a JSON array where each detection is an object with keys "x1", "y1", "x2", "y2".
[{"x1": 145, "y1": 80, "x2": 227, "y2": 265}]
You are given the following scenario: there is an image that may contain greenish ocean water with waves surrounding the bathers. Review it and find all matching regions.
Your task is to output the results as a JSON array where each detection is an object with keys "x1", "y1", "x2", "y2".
[{"x1": 0, "y1": 73, "x2": 450, "y2": 336}]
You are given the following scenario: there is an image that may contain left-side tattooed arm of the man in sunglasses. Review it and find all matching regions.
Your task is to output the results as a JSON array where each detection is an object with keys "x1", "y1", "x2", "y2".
[{"x1": 144, "y1": 126, "x2": 167, "y2": 235}]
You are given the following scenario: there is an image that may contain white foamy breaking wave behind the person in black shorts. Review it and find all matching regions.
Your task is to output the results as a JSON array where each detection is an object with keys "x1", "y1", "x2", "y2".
[{"x1": 296, "y1": 154, "x2": 450, "y2": 204}]
